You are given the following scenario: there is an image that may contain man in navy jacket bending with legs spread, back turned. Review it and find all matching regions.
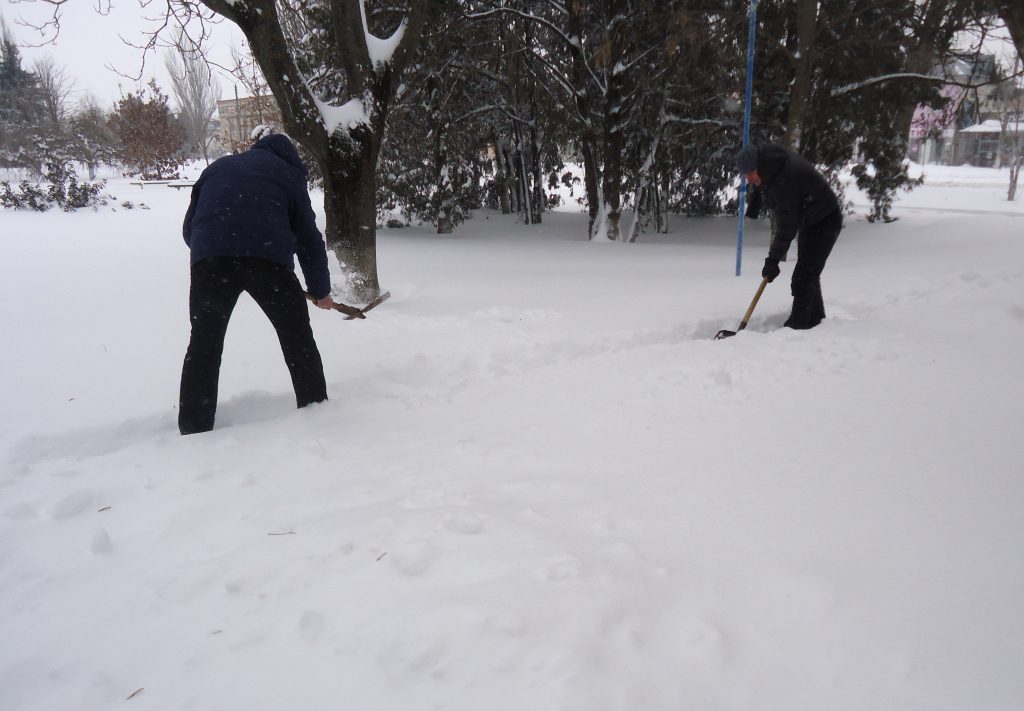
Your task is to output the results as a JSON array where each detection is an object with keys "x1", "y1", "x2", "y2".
[{"x1": 178, "y1": 133, "x2": 334, "y2": 434}]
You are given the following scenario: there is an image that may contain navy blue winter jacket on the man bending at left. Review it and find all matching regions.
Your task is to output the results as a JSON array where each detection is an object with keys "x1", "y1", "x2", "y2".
[{"x1": 182, "y1": 133, "x2": 331, "y2": 298}]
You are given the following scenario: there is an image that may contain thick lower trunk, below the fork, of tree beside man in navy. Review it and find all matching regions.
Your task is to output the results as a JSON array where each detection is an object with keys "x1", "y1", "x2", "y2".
[{"x1": 321, "y1": 139, "x2": 380, "y2": 302}]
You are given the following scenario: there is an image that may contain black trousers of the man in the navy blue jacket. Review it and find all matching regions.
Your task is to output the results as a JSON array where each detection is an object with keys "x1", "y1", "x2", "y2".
[{"x1": 178, "y1": 257, "x2": 327, "y2": 434}]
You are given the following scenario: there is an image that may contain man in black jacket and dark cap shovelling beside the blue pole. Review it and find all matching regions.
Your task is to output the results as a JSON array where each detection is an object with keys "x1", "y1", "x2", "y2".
[{"x1": 736, "y1": 144, "x2": 843, "y2": 329}]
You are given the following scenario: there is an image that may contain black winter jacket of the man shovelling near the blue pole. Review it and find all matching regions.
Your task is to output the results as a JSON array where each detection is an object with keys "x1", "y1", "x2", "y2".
[{"x1": 746, "y1": 144, "x2": 839, "y2": 260}]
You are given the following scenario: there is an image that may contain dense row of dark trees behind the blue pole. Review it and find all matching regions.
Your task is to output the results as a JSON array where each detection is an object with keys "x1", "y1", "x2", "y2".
[{"x1": 376, "y1": 0, "x2": 1019, "y2": 235}]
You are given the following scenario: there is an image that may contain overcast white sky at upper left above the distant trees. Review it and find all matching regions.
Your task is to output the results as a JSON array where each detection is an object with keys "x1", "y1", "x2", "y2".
[{"x1": 6, "y1": 0, "x2": 245, "y2": 107}]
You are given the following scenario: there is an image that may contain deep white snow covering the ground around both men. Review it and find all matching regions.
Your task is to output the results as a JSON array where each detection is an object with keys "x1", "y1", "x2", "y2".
[{"x1": 0, "y1": 166, "x2": 1024, "y2": 711}]
